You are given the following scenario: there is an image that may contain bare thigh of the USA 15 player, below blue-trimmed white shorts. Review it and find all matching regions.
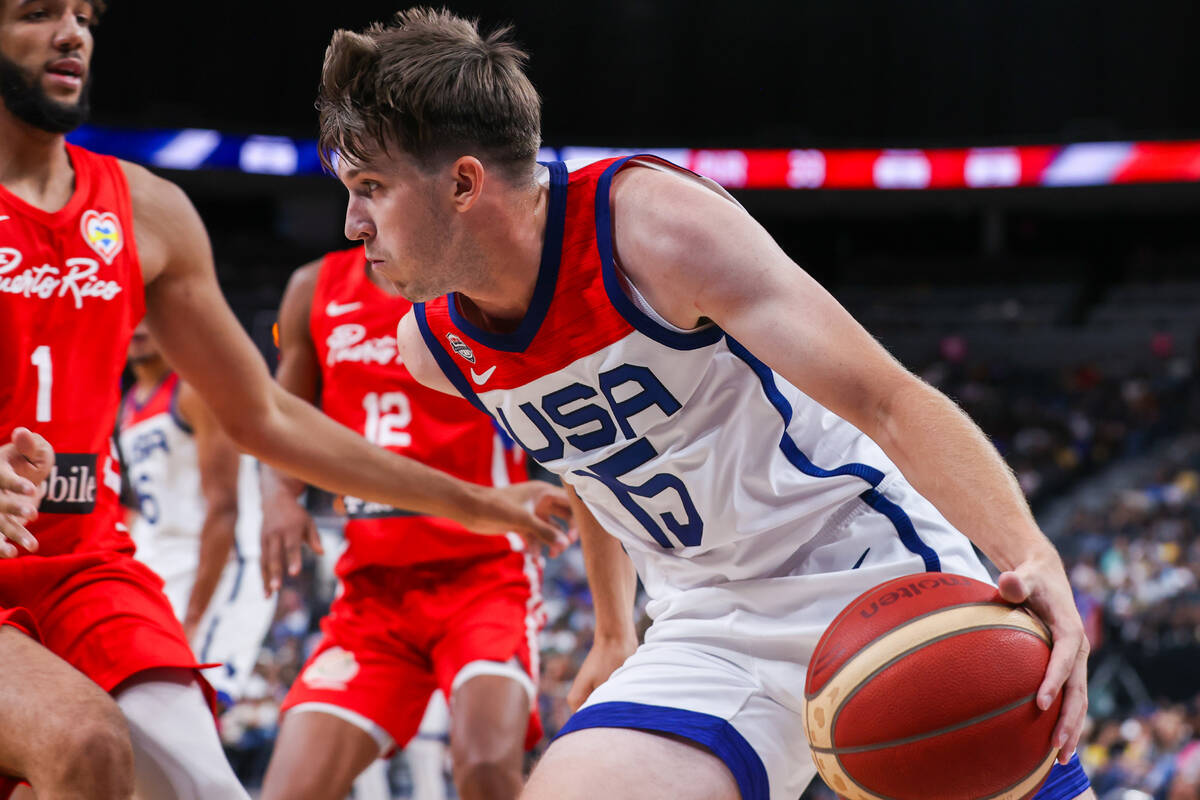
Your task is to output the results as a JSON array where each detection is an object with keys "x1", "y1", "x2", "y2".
[{"x1": 521, "y1": 728, "x2": 742, "y2": 800}]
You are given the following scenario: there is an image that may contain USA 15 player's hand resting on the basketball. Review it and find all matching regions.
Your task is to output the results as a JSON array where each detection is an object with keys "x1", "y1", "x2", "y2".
[{"x1": 997, "y1": 549, "x2": 1090, "y2": 764}]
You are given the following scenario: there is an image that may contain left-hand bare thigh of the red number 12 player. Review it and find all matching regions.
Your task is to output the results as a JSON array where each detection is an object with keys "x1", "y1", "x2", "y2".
[{"x1": 262, "y1": 710, "x2": 379, "y2": 800}]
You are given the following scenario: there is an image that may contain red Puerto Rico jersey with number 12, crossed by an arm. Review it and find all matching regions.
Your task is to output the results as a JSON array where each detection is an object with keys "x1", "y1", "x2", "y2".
[{"x1": 310, "y1": 247, "x2": 527, "y2": 575}]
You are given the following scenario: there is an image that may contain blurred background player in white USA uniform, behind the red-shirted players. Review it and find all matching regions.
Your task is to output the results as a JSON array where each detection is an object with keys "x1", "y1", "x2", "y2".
[{"x1": 118, "y1": 323, "x2": 275, "y2": 705}]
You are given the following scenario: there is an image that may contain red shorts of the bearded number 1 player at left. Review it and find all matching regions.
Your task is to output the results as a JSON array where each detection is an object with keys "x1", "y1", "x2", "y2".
[{"x1": 0, "y1": 552, "x2": 211, "y2": 800}]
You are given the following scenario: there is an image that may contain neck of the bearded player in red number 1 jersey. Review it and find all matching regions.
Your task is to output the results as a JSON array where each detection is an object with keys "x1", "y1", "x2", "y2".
[{"x1": 0, "y1": 112, "x2": 74, "y2": 212}]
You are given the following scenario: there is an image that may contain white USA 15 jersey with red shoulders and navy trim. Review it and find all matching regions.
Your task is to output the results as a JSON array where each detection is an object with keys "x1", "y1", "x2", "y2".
[{"x1": 416, "y1": 160, "x2": 974, "y2": 614}]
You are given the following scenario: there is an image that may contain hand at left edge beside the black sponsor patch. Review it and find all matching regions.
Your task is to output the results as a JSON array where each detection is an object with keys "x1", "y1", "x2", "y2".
[{"x1": 0, "y1": 428, "x2": 54, "y2": 558}]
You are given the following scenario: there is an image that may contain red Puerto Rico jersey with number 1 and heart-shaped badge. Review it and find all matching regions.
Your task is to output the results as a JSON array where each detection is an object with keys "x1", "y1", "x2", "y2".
[{"x1": 0, "y1": 144, "x2": 145, "y2": 555}]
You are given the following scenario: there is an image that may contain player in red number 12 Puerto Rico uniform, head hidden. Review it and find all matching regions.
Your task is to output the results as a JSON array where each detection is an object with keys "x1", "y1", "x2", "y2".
[{"x1": 263, "y1": 247, "x2": 542, "y2": 800}]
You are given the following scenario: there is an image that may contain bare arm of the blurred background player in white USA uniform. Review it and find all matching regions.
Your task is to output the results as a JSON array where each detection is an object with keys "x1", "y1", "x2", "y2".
[{"x1": 179, "y1": 384, "x2": 240, "y2": 639}]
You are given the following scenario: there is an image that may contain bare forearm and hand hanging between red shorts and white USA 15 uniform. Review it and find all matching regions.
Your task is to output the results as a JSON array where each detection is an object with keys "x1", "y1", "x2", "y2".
[{"x1": 566, "y1": 487, "x2": 637, "y2": 710}]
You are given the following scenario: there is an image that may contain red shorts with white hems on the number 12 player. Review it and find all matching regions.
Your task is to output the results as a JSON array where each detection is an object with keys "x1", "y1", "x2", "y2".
[{"x1": 283, "y1": 552, "x2": 544, "y2": 751}]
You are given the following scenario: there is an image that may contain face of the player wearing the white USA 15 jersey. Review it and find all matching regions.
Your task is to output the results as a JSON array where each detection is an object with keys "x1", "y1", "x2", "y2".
[{"x1": 337, "y1": 149, "x2": 473, "y2": 302}]
